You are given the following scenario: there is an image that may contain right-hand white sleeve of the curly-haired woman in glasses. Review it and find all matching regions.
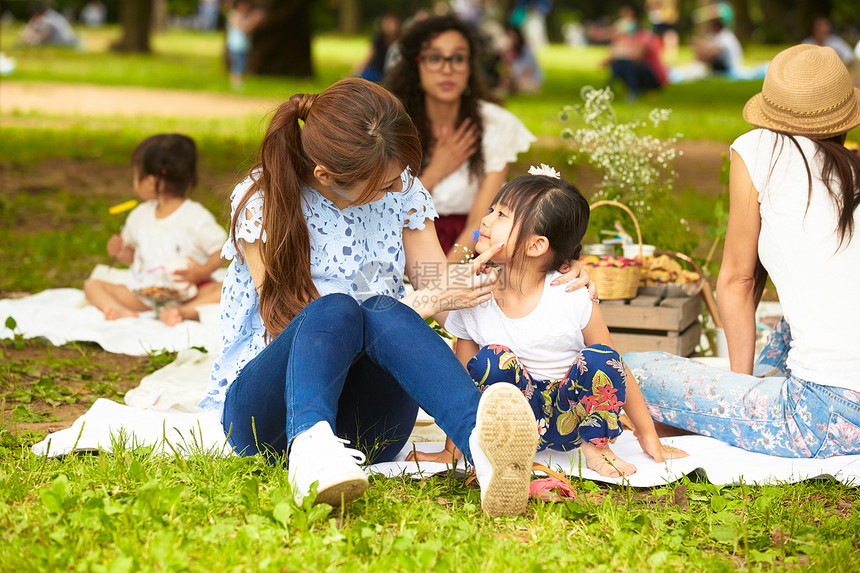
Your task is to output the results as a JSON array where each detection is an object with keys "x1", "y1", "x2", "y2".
[{"x1": 481, "y1": 101, "x2": 537, "y2": 173}]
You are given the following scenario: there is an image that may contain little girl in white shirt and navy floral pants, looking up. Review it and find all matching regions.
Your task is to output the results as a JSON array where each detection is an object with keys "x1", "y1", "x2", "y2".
[{"x1": 410, "y1": 168, "x2": 687, "y2": 477}]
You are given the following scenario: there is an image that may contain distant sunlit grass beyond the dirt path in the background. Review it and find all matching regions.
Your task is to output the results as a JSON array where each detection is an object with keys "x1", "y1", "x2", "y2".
[{"x1": 0, "y1": 26, "x2": 792, "y2": 141}]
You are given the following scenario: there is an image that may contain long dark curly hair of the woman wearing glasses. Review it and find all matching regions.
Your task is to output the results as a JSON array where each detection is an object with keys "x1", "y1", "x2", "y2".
[{"x1": 385, "y1": 16, "x2": 498, "y2": 178}]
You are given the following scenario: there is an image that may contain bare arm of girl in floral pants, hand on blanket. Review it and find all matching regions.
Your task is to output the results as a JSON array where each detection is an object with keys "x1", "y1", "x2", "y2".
[{"x1": 582, "y1": 303, "x2": 689, "y2": 462}]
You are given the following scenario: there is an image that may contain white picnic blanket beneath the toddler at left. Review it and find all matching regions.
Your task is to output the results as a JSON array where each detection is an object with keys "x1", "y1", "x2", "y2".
[{"x1": 0, "y1": 265, "x2": 220, "y2": 356}]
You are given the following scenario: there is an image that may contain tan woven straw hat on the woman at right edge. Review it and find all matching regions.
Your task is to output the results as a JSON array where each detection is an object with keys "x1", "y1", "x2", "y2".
[{"x1": 744, "y1": 44, "x2": 860, "y2": 139}]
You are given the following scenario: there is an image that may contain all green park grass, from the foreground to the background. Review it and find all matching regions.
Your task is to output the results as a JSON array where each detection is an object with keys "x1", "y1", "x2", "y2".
[{"x1": 0, "y1": 22, "x2": 860, "y2": 571}]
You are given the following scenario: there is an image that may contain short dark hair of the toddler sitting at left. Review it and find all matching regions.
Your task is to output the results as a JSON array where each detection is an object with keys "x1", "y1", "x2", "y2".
[{"x1": 131, "y1": 133, "x2": 197, "y2": 197}]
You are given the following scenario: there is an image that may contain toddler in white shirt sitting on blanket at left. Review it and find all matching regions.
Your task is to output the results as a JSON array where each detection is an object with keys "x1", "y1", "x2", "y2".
[{"x1": 84, "y1": 133, "x2": 227, "y2": 326}]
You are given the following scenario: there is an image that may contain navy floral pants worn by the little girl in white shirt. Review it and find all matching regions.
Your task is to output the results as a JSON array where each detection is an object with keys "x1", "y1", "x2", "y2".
[{"x1": 466, "y1": 344, "x2": 627, "y2": 450}]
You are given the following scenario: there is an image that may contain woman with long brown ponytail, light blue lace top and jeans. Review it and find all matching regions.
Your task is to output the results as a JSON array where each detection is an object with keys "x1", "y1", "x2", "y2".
[{"x1": 200, "y1": 78, "x2": 552, "y2": 514}]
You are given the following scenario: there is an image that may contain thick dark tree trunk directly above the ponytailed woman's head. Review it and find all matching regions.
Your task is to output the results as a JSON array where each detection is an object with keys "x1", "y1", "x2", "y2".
[{"x1": 248, "y1": 0, "x2": 314, "y2": 78}]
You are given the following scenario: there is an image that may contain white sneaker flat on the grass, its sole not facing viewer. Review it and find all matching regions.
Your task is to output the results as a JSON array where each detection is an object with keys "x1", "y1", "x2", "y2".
[{"x1": 289, "y1": 421, "x2": 370, "y2": 505}]
